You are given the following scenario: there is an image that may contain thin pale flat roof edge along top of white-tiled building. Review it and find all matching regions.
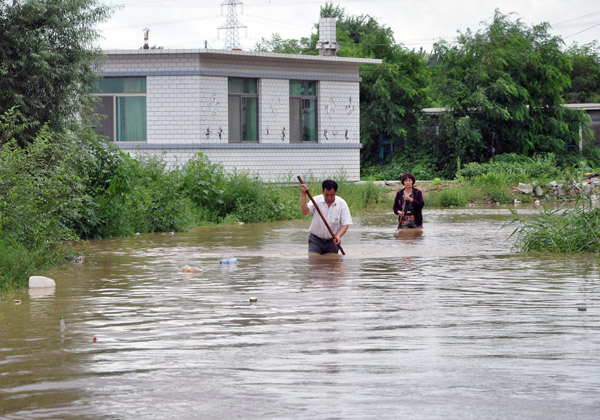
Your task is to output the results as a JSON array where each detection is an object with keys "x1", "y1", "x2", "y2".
[{"x1": 102, "y1": 48, "x2": 382, "y2": 64}]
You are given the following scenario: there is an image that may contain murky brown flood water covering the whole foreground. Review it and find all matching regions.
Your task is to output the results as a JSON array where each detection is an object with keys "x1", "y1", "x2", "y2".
[{"x1": 0, "y1": 209, "x2": 600, "y2": 420}]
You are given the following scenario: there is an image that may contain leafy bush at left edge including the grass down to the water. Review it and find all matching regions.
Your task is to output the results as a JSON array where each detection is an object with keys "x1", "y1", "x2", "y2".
[{"x1": 0, "y1": 128, "x2": 86, "y2": 293}]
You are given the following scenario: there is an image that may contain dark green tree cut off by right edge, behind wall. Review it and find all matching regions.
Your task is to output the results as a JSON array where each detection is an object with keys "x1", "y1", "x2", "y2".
[{"x1": 564, "y1": 42, "x2": 600, "y2": 103}]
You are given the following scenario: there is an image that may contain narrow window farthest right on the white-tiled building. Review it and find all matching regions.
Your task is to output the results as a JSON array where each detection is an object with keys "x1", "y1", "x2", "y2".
[{"x1": 290, "y1": 80, "x2": 317, "y2": 143}]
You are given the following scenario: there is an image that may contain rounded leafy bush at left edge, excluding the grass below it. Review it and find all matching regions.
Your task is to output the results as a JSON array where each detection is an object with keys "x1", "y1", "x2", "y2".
[{"x1": 0, "y1": 128, "x2": 85, "y2": 251}]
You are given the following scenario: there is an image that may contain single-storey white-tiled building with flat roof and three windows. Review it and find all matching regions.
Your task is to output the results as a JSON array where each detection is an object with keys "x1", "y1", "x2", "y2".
[{"x1": 98, "y1": 49, "x2": 381, "y2": 182}]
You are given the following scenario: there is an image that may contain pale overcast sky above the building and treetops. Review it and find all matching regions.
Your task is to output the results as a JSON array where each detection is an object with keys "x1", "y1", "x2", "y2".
[{"x1": 100, "y1": 0, "x2": 600, "y2": 50}]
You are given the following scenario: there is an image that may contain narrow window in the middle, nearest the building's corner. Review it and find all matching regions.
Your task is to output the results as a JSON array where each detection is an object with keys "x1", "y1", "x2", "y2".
[{"x1": 228, "y1": 78, "x2": 258, "y2": 143}]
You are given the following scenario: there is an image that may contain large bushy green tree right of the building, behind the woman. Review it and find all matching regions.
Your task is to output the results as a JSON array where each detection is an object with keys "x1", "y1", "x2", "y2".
[{"x1": 432, "y1": 10, "x2": 585, "y2": 173}]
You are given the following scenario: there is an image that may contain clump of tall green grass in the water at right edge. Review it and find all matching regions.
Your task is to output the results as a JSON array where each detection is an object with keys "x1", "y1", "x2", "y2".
[{"x1": 511, "y1": 199, "x2": 600, "y2": 254}]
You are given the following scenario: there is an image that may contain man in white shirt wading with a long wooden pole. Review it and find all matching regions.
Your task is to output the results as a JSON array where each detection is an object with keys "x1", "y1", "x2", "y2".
[{"x1": 300, "y1": 179, "x2": 352, "y2": 254}]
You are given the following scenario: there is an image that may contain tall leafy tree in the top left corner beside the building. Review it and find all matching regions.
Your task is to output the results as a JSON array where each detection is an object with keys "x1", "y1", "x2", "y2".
[{"x1": 0, "y1": 0, "x2": 110, "y2": 146}]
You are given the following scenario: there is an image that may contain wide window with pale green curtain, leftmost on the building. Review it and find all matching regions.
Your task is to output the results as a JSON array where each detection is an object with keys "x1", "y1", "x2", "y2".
[{"x1": 94, "y1": 77, "x2": 146, "y2": 141}]
